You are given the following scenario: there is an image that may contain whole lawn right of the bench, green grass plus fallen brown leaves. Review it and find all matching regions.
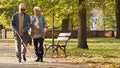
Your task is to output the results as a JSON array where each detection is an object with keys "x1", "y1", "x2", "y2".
[{"x1": 45, "y1": 38, "x2": 120, "y2": 68}]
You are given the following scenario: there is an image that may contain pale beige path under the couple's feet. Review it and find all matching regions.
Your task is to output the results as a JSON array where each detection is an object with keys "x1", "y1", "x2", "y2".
[{"x1": 0, "y1": 43, "x2": 89, "y2": 68}]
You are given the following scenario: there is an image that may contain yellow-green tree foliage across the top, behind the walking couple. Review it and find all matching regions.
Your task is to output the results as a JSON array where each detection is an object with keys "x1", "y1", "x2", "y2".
[{"x1": 0, "y1": 0, "x2": 115, "y2": 29}]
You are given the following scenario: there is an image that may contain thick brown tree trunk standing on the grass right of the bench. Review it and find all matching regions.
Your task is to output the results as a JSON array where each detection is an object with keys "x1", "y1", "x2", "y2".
[{"x1": 77, "y1": 0, "x2": 88, "y2": 49}]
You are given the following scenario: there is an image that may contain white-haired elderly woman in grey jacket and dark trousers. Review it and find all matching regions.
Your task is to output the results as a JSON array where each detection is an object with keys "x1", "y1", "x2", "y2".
[{"x1": 31, "y1": 6, "x2": 47, "y2": 62}]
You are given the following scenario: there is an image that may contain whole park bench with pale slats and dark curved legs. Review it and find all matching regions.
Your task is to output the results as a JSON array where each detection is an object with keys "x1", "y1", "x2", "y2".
[{"x1": 44, "y1": 33, "x2": 71, "y2": 57}]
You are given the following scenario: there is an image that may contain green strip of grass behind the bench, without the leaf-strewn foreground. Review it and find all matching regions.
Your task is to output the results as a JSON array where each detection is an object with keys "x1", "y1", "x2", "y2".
[{"x1": 45, "y1": 38, "x2": 120, "y2": 57}]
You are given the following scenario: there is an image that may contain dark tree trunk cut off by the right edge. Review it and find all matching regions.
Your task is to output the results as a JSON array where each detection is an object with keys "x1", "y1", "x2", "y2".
[{"x1": 116, "y1": 0, "x2": 120, "y2": 38}]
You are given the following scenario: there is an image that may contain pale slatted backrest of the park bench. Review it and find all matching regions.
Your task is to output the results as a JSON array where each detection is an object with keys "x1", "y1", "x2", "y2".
[{"x1": 57, "y1": 33, "x2": 71, "y2": 45}]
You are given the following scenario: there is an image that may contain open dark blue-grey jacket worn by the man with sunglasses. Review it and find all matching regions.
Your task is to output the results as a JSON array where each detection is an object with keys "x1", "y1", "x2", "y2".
[{"x1": 11, "y1": 12, "x2": 30, "y2": 36}]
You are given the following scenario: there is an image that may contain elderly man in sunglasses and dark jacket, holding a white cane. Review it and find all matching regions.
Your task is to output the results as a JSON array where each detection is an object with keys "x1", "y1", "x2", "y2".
[{"x1": 11, "y1": 4, "x2": 30, "y2": 62}]
